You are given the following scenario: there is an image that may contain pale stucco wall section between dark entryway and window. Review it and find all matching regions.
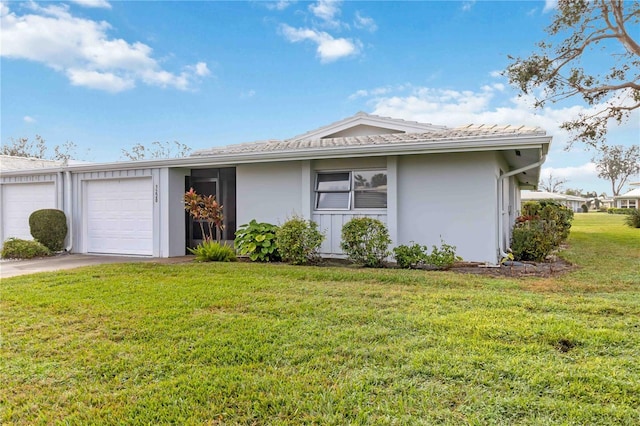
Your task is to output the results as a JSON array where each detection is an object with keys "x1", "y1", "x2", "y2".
[{"x1": 236, "y1": 161, "x2": 309, "y2": 226}]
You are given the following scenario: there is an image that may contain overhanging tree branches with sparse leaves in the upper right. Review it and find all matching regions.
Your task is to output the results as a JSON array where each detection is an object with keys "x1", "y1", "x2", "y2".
[{"x1": 506, "y1": 0, "x2": 640, "y2": 147}]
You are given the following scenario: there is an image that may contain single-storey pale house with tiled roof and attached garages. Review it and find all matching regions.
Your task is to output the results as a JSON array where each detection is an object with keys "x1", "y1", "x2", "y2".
[{"x1": 0, "y1": 113, "x2": 551, "y2": 263}]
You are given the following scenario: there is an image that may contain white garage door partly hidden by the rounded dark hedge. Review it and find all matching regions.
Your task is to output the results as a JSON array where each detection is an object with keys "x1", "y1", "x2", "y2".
[{"x1": 0, "y1": 182, "x2": 56, "y2": 240}]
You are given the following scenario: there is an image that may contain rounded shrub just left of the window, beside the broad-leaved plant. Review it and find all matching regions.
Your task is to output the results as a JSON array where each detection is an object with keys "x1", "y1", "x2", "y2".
[{"x1": 276, "y1": 217, "x2": 324, "y2": 265}]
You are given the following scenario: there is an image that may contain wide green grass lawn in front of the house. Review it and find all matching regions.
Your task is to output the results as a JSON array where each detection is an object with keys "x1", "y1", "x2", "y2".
[{"x1": 0, "y1": 214, "x2": 640, "y2": 425}]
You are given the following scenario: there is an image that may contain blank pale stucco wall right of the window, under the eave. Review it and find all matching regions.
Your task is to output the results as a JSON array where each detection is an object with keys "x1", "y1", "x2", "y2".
[{"x1": 394, "y1": 153, "x2": 499, "y2": 263}]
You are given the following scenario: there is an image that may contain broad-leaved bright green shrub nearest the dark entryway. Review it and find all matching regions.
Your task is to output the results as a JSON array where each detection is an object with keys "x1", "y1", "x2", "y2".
[{"x1": 234, "y1": 219, "x2": 280, "y2": 262}]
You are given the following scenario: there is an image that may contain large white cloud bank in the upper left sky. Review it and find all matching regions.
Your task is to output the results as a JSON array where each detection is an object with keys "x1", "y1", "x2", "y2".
[{"x1": 0, "y1": 3, "x2": 210, "y2": 92}]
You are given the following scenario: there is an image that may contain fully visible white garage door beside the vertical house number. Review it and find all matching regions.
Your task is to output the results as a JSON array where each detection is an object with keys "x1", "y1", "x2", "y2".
[{"x1": 85, "y1": 177, "x2": 153, "y2": 256}]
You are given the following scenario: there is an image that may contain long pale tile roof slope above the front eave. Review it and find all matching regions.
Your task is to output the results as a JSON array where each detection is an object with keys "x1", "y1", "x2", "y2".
[{"x1": 191, "y1": 125, "x2": 546, "y2": 157}]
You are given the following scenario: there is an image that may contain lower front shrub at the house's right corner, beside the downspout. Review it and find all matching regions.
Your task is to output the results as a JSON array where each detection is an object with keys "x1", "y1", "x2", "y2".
[{"x1": 511, "y1": 219, "x2": 555, "y2": 262}]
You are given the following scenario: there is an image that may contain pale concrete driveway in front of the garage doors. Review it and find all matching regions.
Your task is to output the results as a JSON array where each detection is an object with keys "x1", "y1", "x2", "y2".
[{"x1": 0, "y1": 254, "x2": 193, "y2": 278}]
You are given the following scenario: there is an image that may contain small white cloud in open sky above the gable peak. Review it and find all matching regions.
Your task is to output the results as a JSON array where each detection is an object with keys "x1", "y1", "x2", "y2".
[{"x1": 280, "y1": 24, "x2": 361, "y2": 63}]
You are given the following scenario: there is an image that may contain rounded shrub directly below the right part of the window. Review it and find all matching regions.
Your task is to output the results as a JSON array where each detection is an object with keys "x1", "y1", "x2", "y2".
[{"x1": 340, "y1": 217, "x2": 391, "y2": 268}]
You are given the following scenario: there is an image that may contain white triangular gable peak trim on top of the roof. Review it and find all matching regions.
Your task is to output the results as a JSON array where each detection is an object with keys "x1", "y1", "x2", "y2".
[{"x1": 289, "y1": 111, "x2": 446, "y2": 141}]
